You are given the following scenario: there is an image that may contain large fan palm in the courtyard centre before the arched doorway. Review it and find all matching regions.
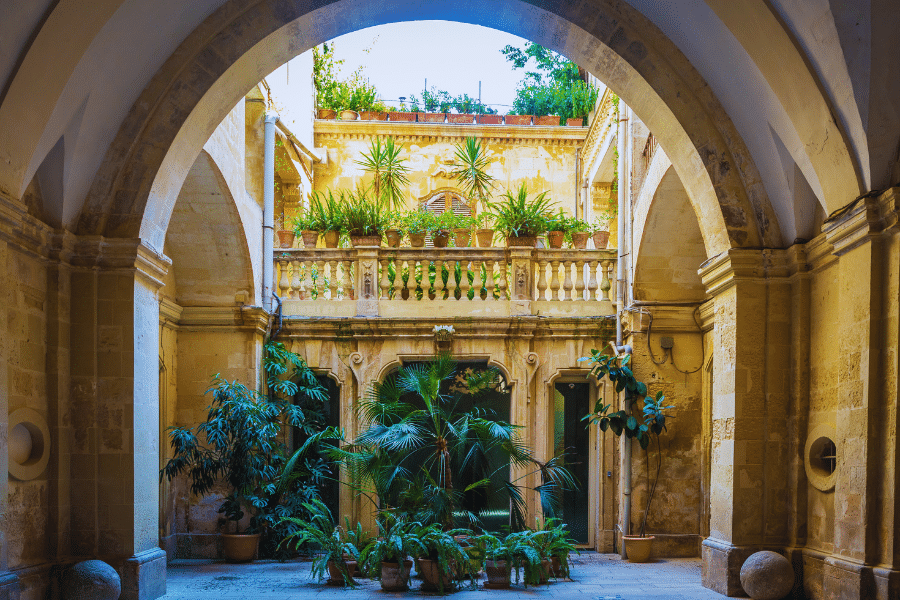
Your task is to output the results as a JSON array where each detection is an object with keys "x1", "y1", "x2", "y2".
[{"x1": 337, "y1": 355, "x2": 575, "y2": 529}]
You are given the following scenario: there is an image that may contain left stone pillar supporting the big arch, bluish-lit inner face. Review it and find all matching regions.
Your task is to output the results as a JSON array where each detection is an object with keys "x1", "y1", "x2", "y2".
[{"x1": 68, "y1": 238, "x2": 169, "y2": 600}]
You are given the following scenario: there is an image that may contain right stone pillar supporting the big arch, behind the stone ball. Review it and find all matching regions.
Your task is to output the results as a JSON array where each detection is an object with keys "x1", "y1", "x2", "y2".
[{"x1": 700, "y1": 249, "x2": 790, "y2": 596}]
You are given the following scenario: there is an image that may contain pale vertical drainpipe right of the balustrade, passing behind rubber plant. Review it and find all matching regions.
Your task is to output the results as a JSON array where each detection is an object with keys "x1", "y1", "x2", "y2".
[{"x1": 616, "y1": 101, "x2": 631, "y2": 558}]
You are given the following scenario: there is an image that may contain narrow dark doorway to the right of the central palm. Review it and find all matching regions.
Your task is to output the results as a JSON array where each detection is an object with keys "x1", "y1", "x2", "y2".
[{"x1": 553, "y1": 382, "x2": 590, "y2": 544}]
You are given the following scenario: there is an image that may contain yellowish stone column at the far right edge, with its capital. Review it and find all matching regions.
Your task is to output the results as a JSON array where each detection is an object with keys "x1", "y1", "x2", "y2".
[{"x1": 823, "y1": 188, "x2": 900, "y2": 599}]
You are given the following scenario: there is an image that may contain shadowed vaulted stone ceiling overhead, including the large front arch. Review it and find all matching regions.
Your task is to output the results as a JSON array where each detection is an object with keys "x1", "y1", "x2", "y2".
[{"x1": 0, "y1": 0, "x2": 900, "y2": 254}]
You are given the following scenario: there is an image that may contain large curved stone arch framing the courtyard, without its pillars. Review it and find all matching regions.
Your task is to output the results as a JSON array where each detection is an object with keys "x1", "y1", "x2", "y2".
[{"x1": 72, "y1": 0, "x2": 781, "y2": 255}]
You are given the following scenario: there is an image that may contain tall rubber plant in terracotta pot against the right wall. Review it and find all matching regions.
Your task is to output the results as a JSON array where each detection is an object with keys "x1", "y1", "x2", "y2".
[{"x1": 581, "y1": 350, "x2": 674, "y2": 562}]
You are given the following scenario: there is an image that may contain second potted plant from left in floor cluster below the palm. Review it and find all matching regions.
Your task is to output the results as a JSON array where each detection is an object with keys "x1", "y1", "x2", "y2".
[{"x1": 360, "y1": 511, "x2": 425, "y2": 592}]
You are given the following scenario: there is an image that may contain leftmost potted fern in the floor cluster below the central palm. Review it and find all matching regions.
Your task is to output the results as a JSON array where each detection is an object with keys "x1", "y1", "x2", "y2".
[{"x1": 279, "y1": 498, "x2": 359, "y2": 586}]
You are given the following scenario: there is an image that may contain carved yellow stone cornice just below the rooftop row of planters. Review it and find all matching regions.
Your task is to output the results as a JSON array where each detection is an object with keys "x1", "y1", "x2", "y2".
[{"x1": 313, "y1": 120, "x2": 587, "y2": 148}]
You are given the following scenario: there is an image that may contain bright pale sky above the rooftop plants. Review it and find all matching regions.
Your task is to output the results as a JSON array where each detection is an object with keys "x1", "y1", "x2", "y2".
[{"x1": 266, "y1": 21, "x2": 525, "y2": 123}]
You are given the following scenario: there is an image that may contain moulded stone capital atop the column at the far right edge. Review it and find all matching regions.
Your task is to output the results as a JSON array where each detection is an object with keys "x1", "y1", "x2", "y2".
[{"x1": 822, "y1": 187, "x2": 900, "y2": 256}]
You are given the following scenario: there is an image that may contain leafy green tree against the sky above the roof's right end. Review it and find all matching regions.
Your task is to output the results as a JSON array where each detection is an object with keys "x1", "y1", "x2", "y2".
[{"x1": 502, "y1": 42, "x2": 599, "y2": 123}]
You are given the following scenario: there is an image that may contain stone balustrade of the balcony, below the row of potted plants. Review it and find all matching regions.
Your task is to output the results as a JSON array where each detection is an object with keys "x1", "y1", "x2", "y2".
[{"x1": 275, "y1": 246, "x2": 616, "y2": 318}]
